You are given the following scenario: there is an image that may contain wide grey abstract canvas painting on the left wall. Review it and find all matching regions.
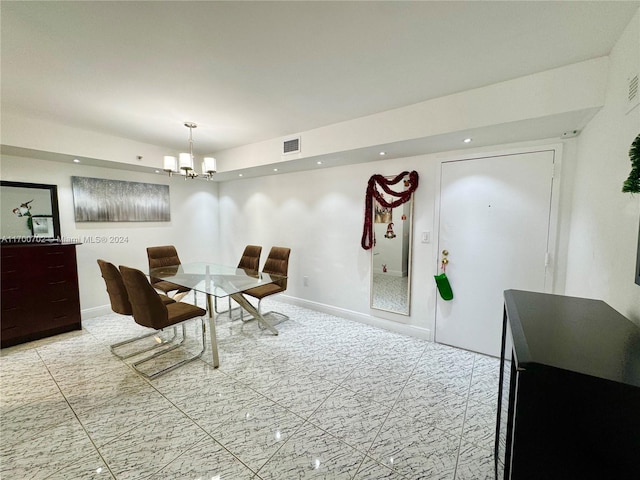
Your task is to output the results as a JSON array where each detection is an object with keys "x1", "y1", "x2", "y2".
[{"x1": 71, "y1": 177, "x2": 171, "y2": 222}]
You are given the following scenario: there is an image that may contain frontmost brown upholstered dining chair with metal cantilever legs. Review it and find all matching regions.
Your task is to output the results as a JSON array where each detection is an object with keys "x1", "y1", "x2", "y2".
[{"x1": 120, "y1": 265, "x2": 206, "y2": 378}]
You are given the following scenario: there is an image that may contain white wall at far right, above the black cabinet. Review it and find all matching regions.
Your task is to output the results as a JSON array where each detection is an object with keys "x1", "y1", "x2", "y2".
[{"x1": 566, "y1": 12, "x2": 640, "y2": 325}]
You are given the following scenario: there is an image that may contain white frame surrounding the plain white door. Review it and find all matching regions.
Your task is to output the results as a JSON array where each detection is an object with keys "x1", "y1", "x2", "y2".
[{"x1": 432, "y1": 143, "x2": 563, "y2": 342}]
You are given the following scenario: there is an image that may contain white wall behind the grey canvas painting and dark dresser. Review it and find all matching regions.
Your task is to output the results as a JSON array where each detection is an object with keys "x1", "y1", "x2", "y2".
[{"x1": 0, "y1": 155, "x2": 221, "y2": 318}]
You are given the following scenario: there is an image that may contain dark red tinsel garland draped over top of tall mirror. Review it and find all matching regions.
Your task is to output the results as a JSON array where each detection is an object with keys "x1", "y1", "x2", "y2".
[{"x1": 360, "y1": 170, "x2": 418, "y2": 250}]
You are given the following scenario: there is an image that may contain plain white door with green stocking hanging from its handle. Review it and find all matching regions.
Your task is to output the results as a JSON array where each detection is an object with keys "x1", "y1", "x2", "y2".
[{"x1": 435, "y1": 150, "x2": 554, "y2": 356}]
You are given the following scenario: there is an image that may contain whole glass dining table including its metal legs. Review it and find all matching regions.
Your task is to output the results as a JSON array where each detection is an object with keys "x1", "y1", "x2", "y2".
[{"x1": 149, "y1": 262, "x2": 286, "y2": 368}]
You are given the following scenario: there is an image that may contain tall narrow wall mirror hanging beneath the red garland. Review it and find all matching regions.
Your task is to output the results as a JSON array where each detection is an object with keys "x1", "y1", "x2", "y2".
[{"x1": 370, "y1": 194, "x2": 413, "y2": 315}]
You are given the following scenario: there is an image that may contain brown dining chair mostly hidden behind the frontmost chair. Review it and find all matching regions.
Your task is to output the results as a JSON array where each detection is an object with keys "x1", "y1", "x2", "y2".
[{"x1": 97, "y1": 259, "x2": 176, "y2": 359}]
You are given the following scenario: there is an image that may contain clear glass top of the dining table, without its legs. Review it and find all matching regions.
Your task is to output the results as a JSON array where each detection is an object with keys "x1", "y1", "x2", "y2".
[{"x1": 149, "y1": 262, "x2": 286, "y2": 297}]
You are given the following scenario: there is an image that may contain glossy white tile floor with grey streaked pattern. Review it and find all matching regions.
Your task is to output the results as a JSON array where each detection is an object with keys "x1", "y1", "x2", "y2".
[{"x1": 0, "y1": 301, "x2": 498, "y2": 480}]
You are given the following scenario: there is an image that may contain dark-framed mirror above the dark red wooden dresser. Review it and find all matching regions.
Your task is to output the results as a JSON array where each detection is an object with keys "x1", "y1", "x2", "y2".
[{"x1": 0, "y1": 180, "x2": 60, "y2": 243}]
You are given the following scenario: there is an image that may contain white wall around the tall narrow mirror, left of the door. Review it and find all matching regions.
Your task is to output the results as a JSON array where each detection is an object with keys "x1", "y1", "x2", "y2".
[{"x1": 220, "y1": 156, "x2": 438, "y2": 336}]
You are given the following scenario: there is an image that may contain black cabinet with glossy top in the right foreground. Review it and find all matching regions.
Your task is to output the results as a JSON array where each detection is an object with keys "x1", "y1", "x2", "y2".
[{"x1": 495, "y1": 290, "x2": 640, "y2": 480}]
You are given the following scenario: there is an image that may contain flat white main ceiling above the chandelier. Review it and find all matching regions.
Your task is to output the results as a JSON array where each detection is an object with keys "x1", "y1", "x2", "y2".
[{"x1": 1, "y1": 1, "x2": 640, "y2": 169}]
